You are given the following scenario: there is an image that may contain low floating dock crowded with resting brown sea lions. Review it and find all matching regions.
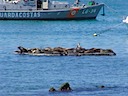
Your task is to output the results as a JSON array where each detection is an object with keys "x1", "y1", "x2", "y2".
[{"x1": 15, "y1": 46, "x2": 116, "y2": 56}]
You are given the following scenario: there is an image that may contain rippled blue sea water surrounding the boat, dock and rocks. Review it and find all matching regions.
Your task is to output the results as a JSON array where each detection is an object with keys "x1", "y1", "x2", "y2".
[{"x1": 0, "y1": 0, "x2": 128, "y2": 96}]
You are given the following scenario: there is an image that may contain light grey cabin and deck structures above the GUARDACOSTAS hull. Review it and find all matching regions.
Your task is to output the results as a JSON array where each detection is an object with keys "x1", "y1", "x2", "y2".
[{"x1": 0, "y1": 0, "x2": 70, "y2": 10}]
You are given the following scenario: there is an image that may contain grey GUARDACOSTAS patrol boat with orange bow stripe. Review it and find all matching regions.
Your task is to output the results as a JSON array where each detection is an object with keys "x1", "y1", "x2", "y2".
[{"x1": 0, "y1": 0, "x2": 104, "y2": 20}]
